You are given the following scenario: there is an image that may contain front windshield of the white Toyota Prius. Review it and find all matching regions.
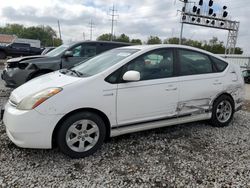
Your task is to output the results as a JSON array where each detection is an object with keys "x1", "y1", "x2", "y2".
[{"x1": 72, "y1": 49, "x2": 139, "y2": 77}]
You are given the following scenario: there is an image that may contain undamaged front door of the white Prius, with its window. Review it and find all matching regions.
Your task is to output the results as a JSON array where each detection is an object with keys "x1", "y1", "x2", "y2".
[{"x1": 117, "y1": 49, "x2": 178, "y2": 126}]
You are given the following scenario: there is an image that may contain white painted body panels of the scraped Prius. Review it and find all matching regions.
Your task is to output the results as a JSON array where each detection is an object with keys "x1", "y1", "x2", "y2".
[{"x1": 3, "y1": 45, "x2": 244, "y2": 148}]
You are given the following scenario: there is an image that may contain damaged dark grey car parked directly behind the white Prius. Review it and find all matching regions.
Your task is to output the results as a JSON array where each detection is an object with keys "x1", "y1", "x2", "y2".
[{"x1": 1, "y1": 41, "x2": 130, "y2": 88}]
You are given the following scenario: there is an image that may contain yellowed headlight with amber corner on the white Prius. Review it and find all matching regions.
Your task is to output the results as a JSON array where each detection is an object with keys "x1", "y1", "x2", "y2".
[{"x1": 16, "y1": 88, "x2": 62, "y2": 110}]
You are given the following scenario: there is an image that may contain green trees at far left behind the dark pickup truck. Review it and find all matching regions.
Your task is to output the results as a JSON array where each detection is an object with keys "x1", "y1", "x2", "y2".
[{"x1": 0, "y1": 24, "x2": 62, "y2": 46}]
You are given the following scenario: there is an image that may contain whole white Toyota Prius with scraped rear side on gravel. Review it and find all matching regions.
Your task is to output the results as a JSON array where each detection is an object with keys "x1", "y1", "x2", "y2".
[{"x1": 3, "y1": 45, "x2": 244, "y2": 158}]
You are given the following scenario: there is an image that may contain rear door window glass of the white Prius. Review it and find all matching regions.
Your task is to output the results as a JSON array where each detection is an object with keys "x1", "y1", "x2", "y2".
[{"x1": 179, "y1": 50, "x2": 213, "y2": 76}]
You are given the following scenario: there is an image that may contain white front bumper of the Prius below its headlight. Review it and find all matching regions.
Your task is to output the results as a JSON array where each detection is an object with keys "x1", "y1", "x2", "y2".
[{"x1": 3, "y1": 102, "x2": 62, "y2": 149}]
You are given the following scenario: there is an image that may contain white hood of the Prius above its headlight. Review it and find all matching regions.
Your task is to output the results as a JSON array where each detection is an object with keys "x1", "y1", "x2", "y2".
[{"x1": 10, "y1": 71, "x2": 83, "y2": 103}]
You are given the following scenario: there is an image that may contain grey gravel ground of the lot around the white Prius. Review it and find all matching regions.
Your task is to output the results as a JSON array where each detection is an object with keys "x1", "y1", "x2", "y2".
[{"x1": 0, "y1": 76, "x2": 250, "y2": 187}]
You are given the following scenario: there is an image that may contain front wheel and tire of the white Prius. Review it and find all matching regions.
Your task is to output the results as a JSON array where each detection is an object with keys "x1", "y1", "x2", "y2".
[{"x1": 56, "y1": 112, "x2": 106, "y2": 158}]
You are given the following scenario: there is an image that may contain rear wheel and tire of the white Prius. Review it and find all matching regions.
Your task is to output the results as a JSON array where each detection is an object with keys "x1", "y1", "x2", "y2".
[{"x1": 210, "y1": 95, "x2": 234, "y2": 127}]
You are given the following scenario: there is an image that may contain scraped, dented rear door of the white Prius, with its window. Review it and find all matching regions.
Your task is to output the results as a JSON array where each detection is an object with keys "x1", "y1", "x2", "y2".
[{"x1": 178, "y1": 49, "x2": 223, "y2": 115}]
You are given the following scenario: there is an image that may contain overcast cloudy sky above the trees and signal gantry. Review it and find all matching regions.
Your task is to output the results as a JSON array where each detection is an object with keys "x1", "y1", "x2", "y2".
[{"x1": 0, "y1": 0, "x2": 250, "y2": 54}]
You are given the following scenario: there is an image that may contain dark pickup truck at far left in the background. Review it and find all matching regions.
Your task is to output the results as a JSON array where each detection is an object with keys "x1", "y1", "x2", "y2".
[{"x1": 0, "y1": 43, "x2": 42, "y2": 59}]
